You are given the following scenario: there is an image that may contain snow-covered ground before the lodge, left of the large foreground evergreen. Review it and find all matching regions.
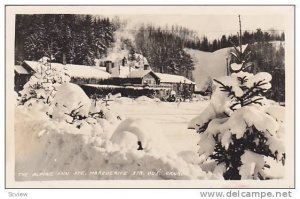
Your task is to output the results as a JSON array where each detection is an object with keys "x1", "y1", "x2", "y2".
[{"x1": 15, "y1": 83, "x2": 217, "y2": 180}]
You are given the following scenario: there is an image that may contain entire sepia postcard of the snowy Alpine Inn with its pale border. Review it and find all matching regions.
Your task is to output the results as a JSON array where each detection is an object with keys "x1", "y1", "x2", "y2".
[{"x1": 5, "y1": 5, "x2": 295, "y2": 188}]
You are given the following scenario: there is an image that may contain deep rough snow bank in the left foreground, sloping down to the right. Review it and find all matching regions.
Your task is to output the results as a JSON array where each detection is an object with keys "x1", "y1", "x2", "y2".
[{"x1": 15, "y1": 84, "x2": 217, "y2": 180}]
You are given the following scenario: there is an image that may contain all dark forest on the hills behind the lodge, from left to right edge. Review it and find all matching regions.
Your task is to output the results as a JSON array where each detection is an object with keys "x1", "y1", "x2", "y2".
[{"x1": 15, "y1": 14, "x2": 285, "y2": 101}]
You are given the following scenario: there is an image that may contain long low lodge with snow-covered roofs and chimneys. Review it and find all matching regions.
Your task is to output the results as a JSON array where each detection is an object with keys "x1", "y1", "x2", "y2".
[{"x1": 15, "y1": 58, "x2": 195, "y2": 97}]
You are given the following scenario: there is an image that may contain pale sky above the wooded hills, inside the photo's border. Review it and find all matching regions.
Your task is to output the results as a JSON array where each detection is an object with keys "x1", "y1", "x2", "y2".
[{"x1": 121, "y1": 15, "x2": 285, "y2": 40}]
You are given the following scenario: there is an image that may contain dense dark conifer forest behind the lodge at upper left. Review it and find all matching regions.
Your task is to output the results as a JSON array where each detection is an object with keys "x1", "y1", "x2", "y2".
[{"x1": 15, "y1": 14, "x2": 117, "y2": 65}]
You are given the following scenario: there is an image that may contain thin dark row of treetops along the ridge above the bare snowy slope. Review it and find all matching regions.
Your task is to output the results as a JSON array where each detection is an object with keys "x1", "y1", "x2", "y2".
[{"x1": 185, "y1": 29, "x2": 285, "y2": 52}]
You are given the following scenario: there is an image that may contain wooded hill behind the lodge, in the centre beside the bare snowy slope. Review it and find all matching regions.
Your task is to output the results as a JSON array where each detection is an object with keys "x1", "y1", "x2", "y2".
[{"x1": 133, "y1": 25, "x2": 194, "y2": 79}]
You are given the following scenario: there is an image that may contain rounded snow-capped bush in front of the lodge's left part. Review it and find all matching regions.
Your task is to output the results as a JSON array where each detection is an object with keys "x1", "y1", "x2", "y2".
[{"x1": 51, "y1": 83, "x2": 121, "y2": 140}]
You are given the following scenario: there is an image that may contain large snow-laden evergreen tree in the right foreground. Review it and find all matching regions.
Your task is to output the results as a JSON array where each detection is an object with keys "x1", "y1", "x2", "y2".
[{"x1": 189, "y1": 42, "x2": 285, "y2": 180}]
